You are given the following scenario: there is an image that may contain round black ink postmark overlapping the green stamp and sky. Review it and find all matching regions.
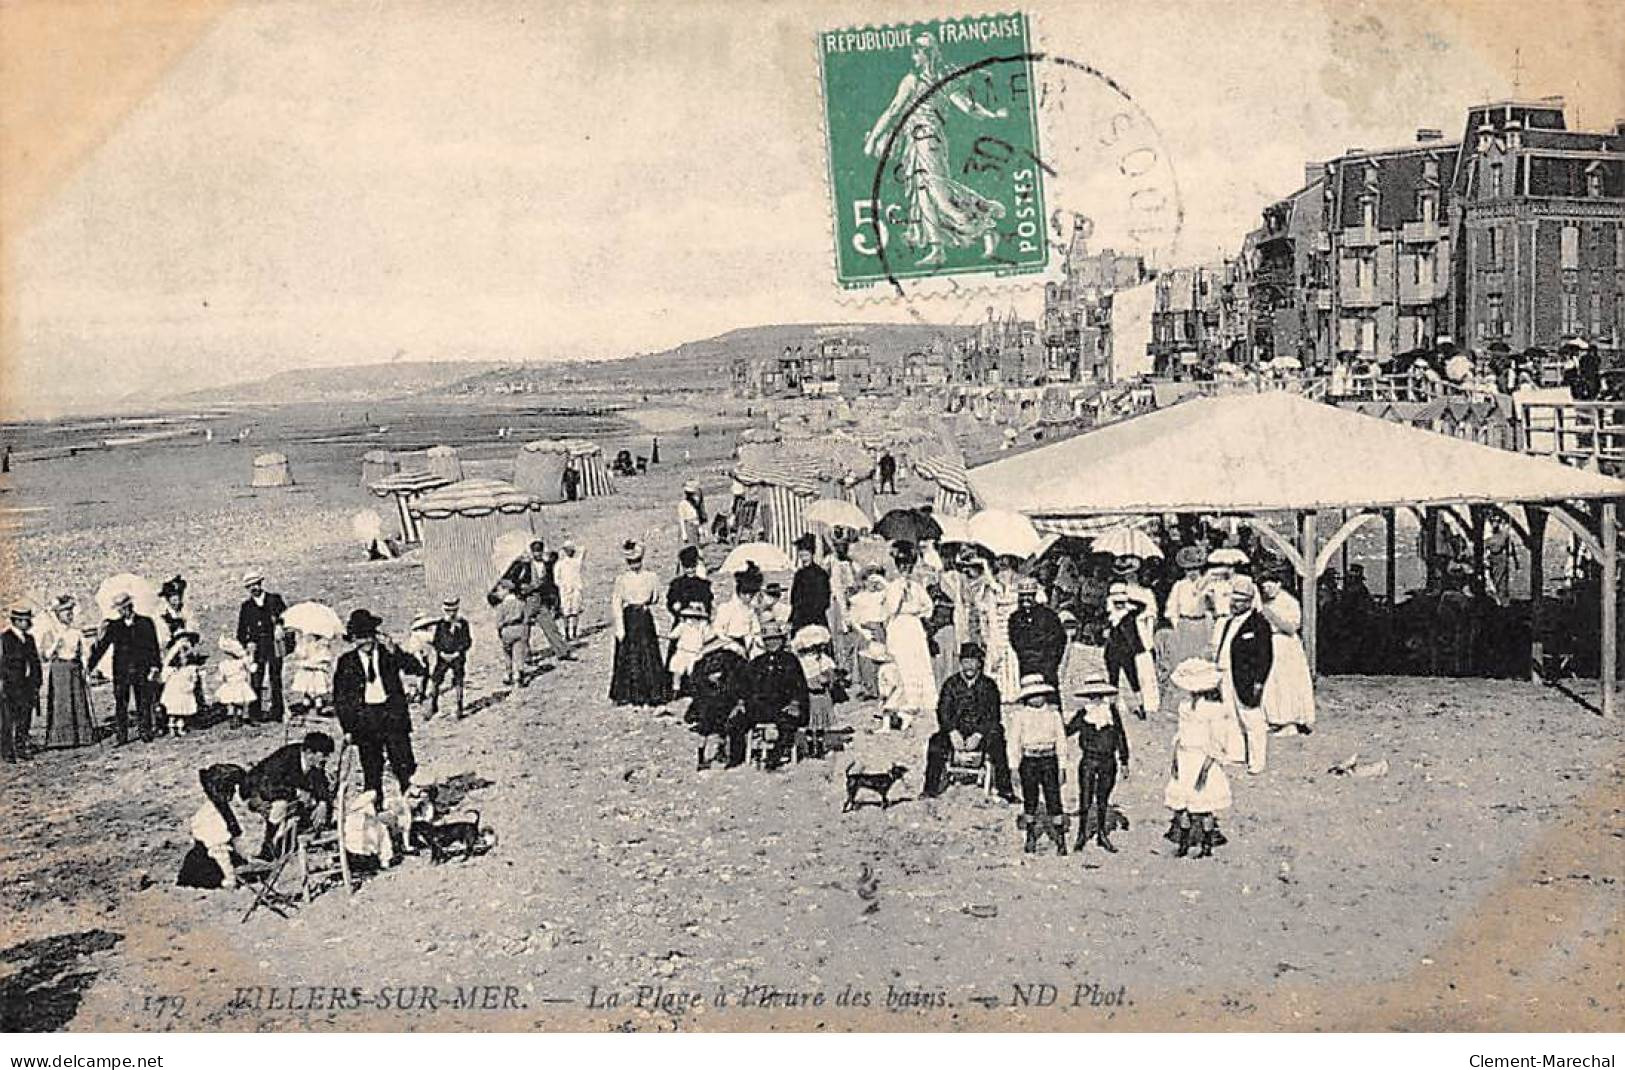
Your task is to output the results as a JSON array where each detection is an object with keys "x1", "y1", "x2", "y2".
[{"x1": 868, "y1": 52, "x2": 1185, "y2": 310}]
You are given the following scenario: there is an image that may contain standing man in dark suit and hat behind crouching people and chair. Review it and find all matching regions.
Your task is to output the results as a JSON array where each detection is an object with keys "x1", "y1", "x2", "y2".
[{"x1": 333, "y1": 610, "x2": 418, "y2": 805}]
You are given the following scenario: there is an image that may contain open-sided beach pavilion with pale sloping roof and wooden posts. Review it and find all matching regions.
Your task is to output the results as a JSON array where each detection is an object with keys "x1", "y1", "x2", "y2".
[{"x1": 970, "y1": 392, "x2": 1625, "y2": 717}]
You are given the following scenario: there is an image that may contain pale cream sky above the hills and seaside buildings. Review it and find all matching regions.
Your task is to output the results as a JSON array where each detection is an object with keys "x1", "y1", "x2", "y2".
[{"x1": 0, "y1": 0, "x2": 1625, "y2": 413}]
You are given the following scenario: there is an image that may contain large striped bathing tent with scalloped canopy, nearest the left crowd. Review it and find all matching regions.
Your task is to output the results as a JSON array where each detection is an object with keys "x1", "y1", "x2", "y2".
[{"x1": 410, "y1": 480, "x2": 541, "y2": 605}]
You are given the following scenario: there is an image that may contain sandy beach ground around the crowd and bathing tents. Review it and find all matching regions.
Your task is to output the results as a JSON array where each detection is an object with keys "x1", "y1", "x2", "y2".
[{"x1": 0, "y1": 398, "x2": 1625, "y2": 1031}]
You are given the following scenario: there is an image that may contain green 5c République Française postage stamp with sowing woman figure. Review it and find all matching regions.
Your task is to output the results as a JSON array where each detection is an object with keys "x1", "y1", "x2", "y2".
[{"x1": 819, "y1": 15, "x2": 1048, "y2": 288}]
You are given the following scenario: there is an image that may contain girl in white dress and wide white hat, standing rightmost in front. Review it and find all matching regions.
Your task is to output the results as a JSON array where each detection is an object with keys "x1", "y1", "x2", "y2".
[{"x1": 1162, "y1": 657, "x2": 1235, "y2": 859}]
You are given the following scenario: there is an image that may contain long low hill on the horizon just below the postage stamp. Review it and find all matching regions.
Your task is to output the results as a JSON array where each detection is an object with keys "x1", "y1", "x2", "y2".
[{"x1": 450, "y1": 324, "x2": 964, "y2": 394}]
